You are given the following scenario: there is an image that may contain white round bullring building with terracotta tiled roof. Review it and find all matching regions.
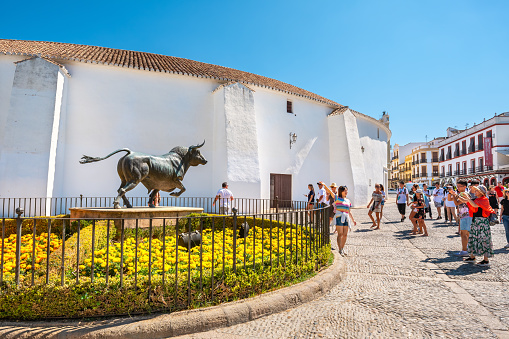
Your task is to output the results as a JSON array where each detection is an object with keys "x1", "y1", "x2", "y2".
[{"x1": 0, "y1": 40, "x2": 391, "y2": 206}]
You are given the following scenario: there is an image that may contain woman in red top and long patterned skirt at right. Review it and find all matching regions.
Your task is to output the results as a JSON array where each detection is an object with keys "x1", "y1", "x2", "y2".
[{"x1": 458, "y1": 185, "x2": 494, "y2": 266}]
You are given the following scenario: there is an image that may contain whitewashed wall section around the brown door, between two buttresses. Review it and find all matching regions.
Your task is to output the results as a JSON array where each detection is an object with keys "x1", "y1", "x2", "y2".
[{"x1": 254, "y1": 87, "x2": 332, "y2": 200}]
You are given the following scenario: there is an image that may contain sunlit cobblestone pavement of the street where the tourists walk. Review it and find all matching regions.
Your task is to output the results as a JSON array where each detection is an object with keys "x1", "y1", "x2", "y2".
[{"x1": 175, "y1": 197, "x2": 509, "y2": 339}]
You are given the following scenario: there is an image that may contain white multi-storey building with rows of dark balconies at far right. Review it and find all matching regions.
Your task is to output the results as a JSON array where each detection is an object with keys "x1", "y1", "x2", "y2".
[{"x1": 438, "y1": 112, "x2": 509, "y2": 189}]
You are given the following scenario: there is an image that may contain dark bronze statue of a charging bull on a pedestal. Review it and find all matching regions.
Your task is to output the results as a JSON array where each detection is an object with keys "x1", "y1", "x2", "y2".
[{"x1": 80, "y1": 141, "x2": 207, "y2": 208}]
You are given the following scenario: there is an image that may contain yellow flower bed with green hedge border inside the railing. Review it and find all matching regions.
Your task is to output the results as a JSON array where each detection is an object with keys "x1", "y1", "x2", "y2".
[{"x1": 0, "y1": 217, "x2": 331, "y2": 320}]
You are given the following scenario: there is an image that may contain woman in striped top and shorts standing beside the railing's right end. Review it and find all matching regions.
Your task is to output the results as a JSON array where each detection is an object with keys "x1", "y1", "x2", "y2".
[{"x1": 323, "y1": 184, "x2": 357, "y2": 257}]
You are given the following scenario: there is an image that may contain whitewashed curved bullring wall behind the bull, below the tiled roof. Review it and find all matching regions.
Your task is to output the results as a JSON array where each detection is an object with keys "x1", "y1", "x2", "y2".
[{"x1": 0, "y1": 56, "x2": 387, "y2": 205}]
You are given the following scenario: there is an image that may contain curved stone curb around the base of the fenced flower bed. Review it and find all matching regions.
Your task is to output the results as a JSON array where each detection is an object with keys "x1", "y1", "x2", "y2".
[{"x1": 0, "y1": 251, "x2": 346, "y2": 339}]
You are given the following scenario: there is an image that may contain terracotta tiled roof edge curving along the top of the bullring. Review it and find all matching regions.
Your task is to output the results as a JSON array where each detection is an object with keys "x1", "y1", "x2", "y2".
[{"x1": 0, "y1": 39, "x2": 341, "y2": 107}]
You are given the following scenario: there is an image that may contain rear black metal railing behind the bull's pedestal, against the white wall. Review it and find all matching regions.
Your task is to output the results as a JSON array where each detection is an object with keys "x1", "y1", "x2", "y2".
[{"x1": 0, "y1": 196, "x2": 307, "y2": 218}]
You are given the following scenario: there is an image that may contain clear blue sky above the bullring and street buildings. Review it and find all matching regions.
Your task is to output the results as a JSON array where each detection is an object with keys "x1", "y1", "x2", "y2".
[{"x1": 0, "y1": 0, "x2": 509, "y2": 144}]
